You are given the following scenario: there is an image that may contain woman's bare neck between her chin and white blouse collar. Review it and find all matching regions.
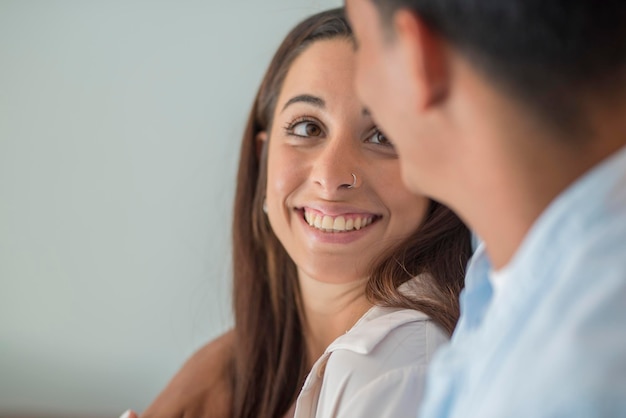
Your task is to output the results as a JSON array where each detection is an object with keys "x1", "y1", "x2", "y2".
[{"x1": 299, "y1": 274, "x2": 372, "y2": 367}]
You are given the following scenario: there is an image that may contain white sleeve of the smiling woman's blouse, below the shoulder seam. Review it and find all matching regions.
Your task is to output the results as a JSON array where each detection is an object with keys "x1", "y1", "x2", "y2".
[{"x1": 315, "y1": 321, "x2": 447, "y2": 418}]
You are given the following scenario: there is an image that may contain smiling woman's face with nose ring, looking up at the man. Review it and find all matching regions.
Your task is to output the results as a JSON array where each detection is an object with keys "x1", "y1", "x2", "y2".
[{"x1": 266, "y1": 38, "x2": 428, "y2": 283}]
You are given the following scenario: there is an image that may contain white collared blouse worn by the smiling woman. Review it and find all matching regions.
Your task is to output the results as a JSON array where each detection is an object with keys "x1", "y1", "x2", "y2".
[{"x1": 295, "y1": 283, "x2": 448, "y2": 418}]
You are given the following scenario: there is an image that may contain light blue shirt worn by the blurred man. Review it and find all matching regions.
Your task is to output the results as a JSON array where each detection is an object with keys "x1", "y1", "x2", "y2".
[{"x1": 420, "y1": 148, "x2": 626, "y2": 418}]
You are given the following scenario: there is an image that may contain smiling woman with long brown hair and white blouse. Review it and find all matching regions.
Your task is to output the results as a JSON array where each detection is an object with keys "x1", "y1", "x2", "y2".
[{"x1": 127, "y1": 9, "x2": 471, "y2": 418}]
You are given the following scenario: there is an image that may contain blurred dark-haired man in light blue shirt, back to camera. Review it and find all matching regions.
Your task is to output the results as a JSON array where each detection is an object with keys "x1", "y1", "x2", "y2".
[{"x1": 346, "y1": 0, "x2": 626, "y2": 418}]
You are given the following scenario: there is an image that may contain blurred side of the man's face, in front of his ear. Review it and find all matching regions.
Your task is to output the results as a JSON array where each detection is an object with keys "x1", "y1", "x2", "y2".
[{"x1": 346, "y1": 0, "x2": 451, "y2": 198}]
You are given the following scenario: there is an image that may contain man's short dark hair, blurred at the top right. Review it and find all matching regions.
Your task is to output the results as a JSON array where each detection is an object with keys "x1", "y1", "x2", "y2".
[{"x1": 365, "y1": 0, "x2": 626, "y2": 140}]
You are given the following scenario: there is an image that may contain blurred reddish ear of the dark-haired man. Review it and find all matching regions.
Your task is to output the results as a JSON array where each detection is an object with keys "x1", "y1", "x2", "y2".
[{"x1": 393, "y1": 9, "x2": 450, "y2": 110}]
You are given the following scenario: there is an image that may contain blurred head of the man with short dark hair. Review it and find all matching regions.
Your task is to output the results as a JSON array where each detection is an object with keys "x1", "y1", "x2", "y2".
[{"x1": 346, "y1": 0, "x2": 626, "y2": 202}]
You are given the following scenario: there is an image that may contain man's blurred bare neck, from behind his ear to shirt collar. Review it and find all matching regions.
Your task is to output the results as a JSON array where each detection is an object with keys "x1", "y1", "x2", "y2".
[{"x1": 442, "y1": 59, "x2": 626, "y2": 269}]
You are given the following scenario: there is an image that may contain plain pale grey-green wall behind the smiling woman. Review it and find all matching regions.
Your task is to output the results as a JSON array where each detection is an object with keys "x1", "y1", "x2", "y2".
[{"x1": 0, "y1": 0, "x2": 341, "y2": 416}]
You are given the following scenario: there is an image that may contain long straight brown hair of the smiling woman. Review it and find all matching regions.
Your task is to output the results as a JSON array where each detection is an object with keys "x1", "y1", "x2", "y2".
[{"x1": 233, "y1": 8, "x2": 469, "y2": 418}]
